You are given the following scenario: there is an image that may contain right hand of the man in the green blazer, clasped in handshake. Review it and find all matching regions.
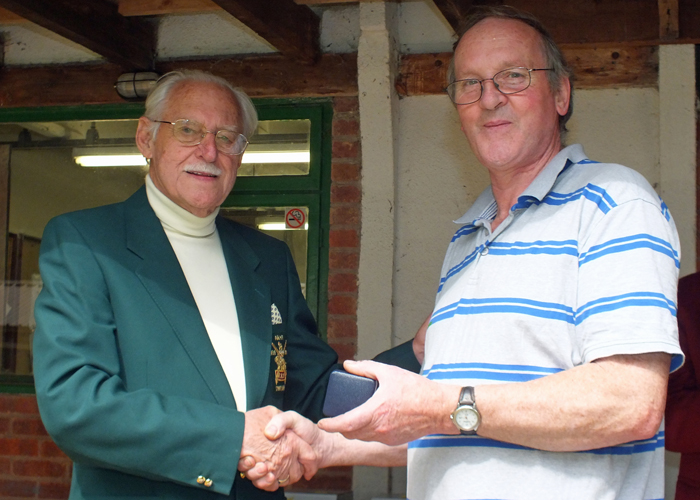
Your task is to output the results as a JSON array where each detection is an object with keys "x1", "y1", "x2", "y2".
[{"x1": 239, "y1": 406, "x2": 317, "y2": 491}]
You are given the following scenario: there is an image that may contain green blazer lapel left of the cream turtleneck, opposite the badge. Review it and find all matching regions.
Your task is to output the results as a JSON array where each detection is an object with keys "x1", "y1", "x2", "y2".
[{"x1": 125, "y1": 187, "x2": 235, "y2": 411}]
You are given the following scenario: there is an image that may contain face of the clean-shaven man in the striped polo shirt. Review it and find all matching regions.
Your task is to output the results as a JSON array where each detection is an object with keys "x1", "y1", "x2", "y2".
[{"x1": 454, "y1": 18, "x2": 569, "y2": 175}]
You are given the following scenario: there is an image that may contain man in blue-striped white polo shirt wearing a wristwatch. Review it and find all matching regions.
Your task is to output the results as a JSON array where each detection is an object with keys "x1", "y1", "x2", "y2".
[{"x1": 242, "y1": 3, "x2": 683, "y2": 500}]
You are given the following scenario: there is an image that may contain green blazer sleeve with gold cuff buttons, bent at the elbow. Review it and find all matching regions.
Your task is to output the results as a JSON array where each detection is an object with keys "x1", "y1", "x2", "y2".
[{"x1": 34, "y1": 217, "x2": 244, "y2": 494}]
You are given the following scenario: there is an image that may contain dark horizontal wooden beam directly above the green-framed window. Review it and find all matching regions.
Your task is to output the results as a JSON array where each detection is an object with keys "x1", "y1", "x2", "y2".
[{"x1": 0, "y1": 54, "x2": 357, "y2": 107}]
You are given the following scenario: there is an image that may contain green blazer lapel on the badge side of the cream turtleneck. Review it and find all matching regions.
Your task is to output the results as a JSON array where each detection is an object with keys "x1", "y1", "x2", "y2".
[{"x1": 217, "y1": 221, "x2": 272, "y2": 408}]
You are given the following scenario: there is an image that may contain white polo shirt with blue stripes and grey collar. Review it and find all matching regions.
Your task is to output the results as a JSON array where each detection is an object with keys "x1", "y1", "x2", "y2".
[{"x1": 408, "y1": 145, "x2": 683, "y2": 500}]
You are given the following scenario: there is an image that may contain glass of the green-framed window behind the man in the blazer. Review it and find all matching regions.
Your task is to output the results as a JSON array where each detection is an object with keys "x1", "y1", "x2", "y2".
[{"x1": 0, "y1": 119, "x2": 311, "y2": 375}]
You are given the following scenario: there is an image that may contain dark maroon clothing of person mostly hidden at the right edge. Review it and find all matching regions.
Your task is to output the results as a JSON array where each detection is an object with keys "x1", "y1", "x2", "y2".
[{"x1": 665, "y1": 273, "x2": 700, "y2": 453}]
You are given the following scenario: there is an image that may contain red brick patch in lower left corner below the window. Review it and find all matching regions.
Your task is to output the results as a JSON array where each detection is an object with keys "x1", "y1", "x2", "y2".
[{"x1": 0, "y1": 394, "x2": 71, "y2": 500}]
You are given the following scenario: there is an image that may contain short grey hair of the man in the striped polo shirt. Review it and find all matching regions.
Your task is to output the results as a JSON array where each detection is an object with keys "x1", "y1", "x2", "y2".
[{"x1": 447, "y1": 5, "x2": 574, "y2": 142}]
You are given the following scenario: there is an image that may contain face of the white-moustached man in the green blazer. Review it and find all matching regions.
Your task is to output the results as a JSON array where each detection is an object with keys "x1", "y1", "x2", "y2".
[{"x1": 136, "y1": 82, "x2": 242, "y2": 217}]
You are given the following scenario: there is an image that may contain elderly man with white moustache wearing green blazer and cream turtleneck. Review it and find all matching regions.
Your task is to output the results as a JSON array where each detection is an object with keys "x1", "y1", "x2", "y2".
[{"x1": 34, "y1": 72, "x2": 337, "y2": 500}]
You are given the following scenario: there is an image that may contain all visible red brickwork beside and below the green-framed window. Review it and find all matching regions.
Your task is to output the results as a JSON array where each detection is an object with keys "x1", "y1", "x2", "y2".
[{"x1": 0, "y1": 97, "x2": 361, "y2": 500}]
